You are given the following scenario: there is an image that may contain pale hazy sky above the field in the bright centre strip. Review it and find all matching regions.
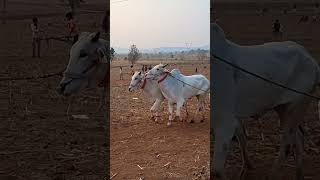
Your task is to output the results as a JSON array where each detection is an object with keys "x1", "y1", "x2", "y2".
[{"x1": 110, "y1": 0, "x2": 210, "y2": 48}]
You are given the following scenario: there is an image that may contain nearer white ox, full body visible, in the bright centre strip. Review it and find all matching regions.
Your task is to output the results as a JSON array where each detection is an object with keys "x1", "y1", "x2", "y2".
[{"x1": 146, "y1": 64, "x2": 210, "y2": 126}]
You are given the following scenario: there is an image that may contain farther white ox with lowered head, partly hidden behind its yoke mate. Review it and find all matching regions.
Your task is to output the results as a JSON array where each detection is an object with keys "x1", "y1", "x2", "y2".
[{"x1": 129, "y1": 71, "x2": 188, "y2": 122}]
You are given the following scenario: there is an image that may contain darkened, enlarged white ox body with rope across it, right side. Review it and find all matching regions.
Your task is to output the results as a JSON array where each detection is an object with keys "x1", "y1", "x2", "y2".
[{"x1": 210, "y1": 23, "x2": 320, "y2": 180}]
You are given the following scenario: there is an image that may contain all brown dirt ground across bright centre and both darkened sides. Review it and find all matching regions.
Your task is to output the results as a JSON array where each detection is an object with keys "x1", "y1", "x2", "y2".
[{"x1": 0, "y1": 0, "x2": 320, "y2": 180}]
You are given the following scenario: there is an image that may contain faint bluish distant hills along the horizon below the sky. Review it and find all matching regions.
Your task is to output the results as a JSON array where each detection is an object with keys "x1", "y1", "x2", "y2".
[{"x1": 114, "y1": 45, "x2": 210, "y2": 54}]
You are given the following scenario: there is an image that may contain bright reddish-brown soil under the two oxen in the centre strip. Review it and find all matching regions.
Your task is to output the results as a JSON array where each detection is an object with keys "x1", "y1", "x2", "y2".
[{"x1": 110, "y1": 62, "x2": 210, "y2": 179}]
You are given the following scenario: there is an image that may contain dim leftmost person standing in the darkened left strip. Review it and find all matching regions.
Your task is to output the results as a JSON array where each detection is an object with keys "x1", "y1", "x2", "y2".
[{"x1": 31, "y1": 17, "x2": 41, "y2": 57}]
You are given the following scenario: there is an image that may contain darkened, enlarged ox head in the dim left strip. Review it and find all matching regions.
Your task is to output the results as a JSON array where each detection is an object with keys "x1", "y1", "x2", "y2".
[{"x1": 57, "y1": 32, "x2": 109, "y2": 107}]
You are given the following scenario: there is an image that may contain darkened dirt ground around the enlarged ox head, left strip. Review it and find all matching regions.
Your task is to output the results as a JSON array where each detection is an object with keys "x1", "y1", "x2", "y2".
[{"x1": 0, "y1": 0, "x2": 108, "y2": 180}]
